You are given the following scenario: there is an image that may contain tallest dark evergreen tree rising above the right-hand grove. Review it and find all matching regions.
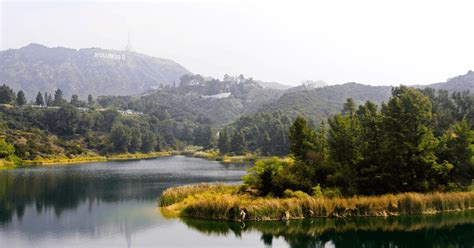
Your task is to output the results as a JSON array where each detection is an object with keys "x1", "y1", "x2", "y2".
[{"x1": 379, "y1": 86, "x2": 445, "y2": 192}]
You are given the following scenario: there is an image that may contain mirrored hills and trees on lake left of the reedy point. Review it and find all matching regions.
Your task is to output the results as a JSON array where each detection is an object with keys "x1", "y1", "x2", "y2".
[{"x1": 0, "y1": 157, "x2": 245, "y2": 239}]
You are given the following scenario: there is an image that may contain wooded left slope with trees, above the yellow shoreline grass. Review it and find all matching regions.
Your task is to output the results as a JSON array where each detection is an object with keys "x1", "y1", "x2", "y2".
[{"x1": 0, "y1": 85, "x2": 215, "y2": 163}]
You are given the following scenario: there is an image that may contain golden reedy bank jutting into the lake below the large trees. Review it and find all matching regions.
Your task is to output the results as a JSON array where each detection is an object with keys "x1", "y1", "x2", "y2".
[{"x1": 160, "y1": 184, "x2": 474, "y2": 220}]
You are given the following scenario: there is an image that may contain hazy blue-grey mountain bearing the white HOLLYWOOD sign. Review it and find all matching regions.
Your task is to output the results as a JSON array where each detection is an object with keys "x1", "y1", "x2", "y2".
[{"x1": 0, "y1": 44, "x2": 190, "y2": 99}]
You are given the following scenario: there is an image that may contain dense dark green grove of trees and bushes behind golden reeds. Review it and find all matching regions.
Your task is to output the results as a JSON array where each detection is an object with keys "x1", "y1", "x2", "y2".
[{"x1": 245, "y1": 86, "x2": 474, "y2": 196}]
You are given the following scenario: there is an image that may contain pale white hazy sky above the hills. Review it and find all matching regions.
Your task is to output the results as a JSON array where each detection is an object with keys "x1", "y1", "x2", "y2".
[{"x1": 0, "y1": 0, "x2": 474, "y2": 85}]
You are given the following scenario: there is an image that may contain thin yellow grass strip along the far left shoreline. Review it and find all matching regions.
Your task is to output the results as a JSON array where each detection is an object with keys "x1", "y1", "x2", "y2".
[{"x1": 23, "y1": 152, "x2": 171, "y2": 166}]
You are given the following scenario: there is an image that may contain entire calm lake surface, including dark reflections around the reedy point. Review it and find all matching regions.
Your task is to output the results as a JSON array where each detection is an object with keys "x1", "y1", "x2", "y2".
[{"x1": 0, "y1": 156, "x2": 474, "y2": 247}]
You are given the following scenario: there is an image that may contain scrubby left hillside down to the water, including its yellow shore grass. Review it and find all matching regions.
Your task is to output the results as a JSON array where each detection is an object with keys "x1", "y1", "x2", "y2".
[{"x1": 0, "y1": 85, "x2": 199, "y2": 166}]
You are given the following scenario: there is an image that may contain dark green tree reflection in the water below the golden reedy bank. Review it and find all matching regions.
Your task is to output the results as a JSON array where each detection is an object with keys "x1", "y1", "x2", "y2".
[{"x1": 181, "y1": 211, "x2": 474, "y2": 248}]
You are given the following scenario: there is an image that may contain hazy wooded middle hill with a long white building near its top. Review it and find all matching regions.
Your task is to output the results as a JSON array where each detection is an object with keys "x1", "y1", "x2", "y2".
[{"x1": 98, "y1": 74, "x2": 284, "y2": 126}]
